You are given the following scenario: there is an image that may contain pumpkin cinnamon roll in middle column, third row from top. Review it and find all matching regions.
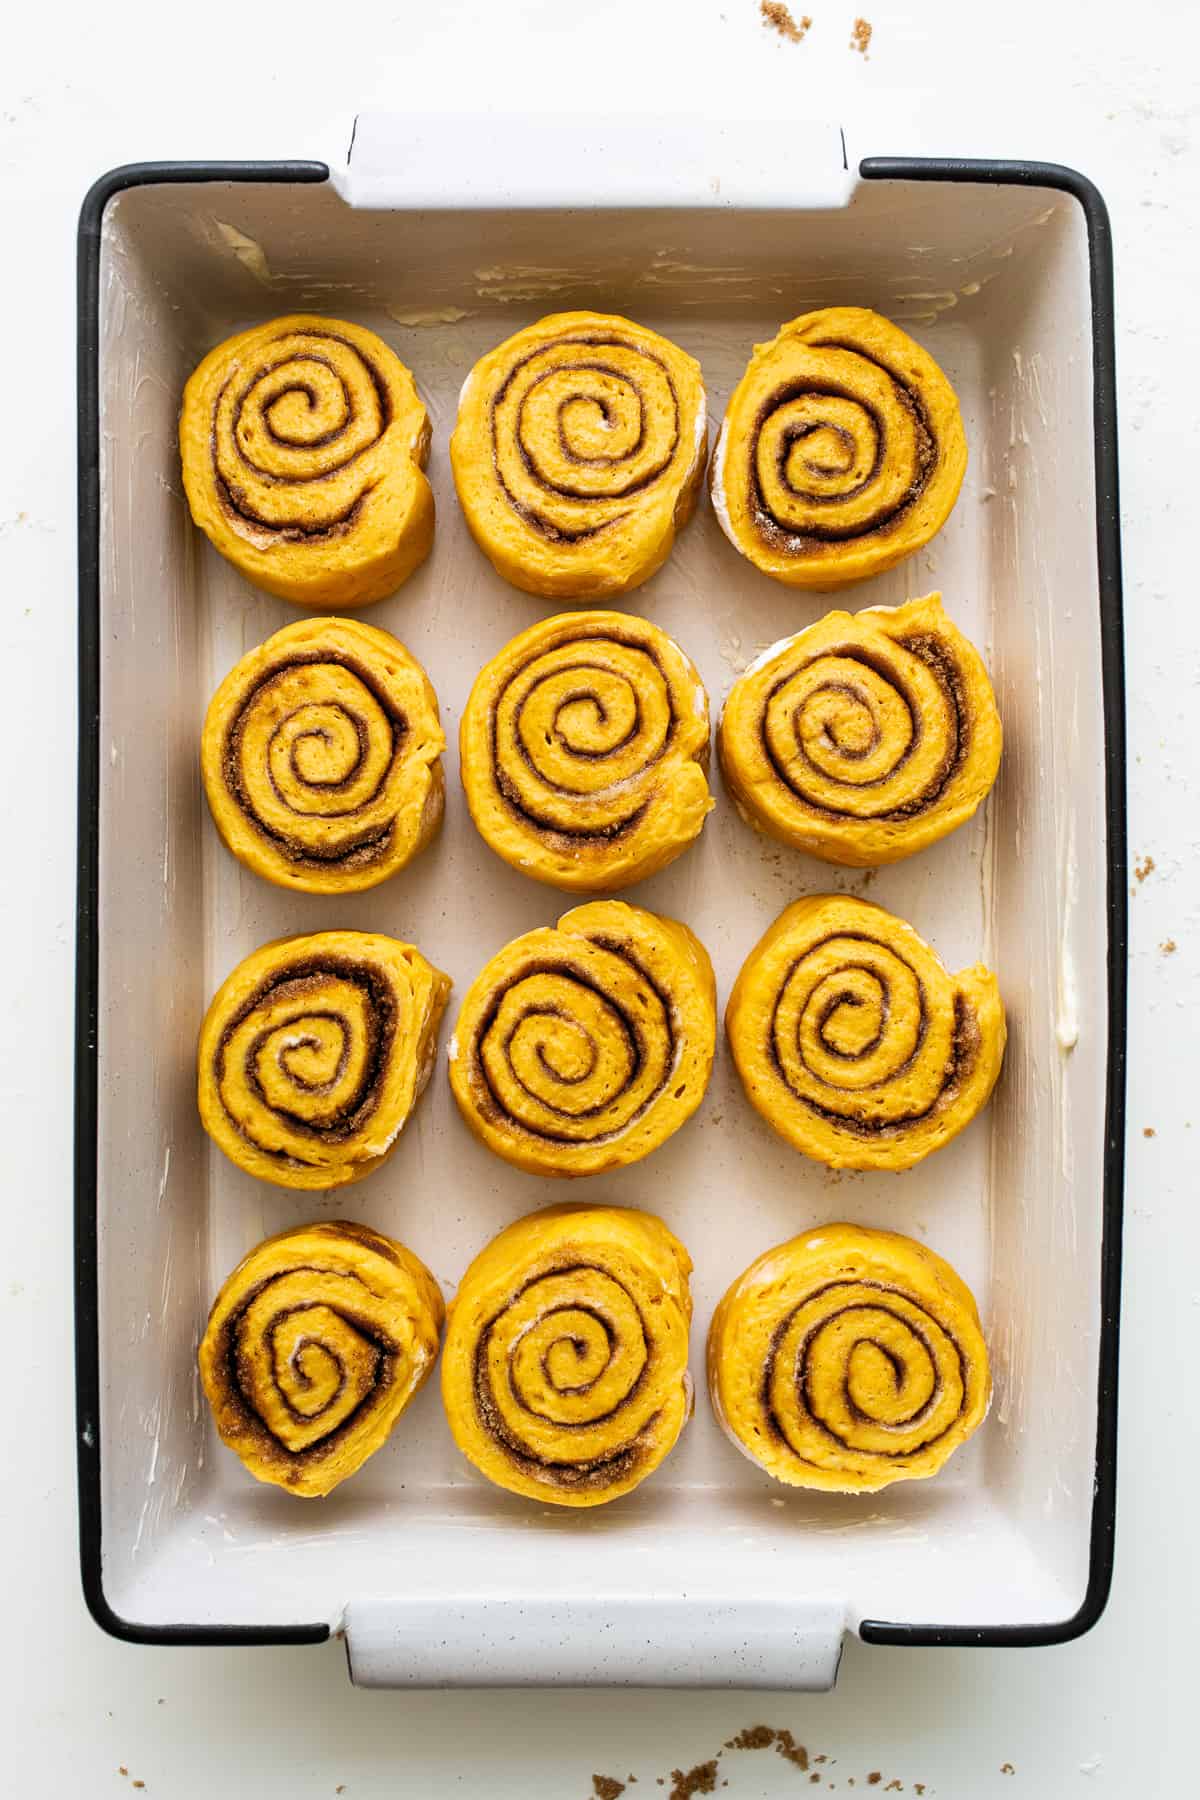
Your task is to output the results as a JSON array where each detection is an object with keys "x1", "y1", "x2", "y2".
[{"x1": 450, "y1": 900, "x2": 716, "y2": 1175}]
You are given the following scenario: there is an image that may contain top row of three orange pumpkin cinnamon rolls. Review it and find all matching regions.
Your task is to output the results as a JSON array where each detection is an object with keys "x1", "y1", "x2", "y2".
[{"x1": 180, "y1": 306, "x2": 966, "y2": 610}]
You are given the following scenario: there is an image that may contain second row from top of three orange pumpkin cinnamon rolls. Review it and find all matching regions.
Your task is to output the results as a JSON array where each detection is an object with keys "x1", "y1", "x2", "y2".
[{"x1": 201, "y1": 594, "x2": 1002, "y2": 893}]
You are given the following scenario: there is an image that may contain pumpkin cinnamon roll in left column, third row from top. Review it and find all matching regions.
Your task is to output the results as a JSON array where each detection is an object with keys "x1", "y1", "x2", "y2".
[{"x1": 198, "y1": 931, "x2": 450, "y2": 1188}]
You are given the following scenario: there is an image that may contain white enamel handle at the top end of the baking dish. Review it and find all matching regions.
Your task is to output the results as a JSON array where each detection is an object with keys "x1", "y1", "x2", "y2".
[{"x1": 331, "y1": 112, "x2": 858, "y2": 212}]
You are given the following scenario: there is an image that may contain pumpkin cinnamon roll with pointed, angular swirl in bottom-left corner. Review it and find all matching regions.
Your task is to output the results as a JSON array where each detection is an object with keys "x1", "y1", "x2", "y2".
[{"x1": 200, "y1": 1224, "x2": 444, "y2": 1499}]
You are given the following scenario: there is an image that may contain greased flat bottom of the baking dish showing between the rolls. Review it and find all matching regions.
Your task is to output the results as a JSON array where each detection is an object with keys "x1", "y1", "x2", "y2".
[{"x1": 180, "y1": 311, "x2": 1004, "y2": 1532}]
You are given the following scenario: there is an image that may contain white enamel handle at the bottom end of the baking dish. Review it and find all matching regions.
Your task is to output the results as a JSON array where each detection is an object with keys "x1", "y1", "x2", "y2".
[{"x1": 344, "y1": 1593, "x2": 846, "y2": 1692}]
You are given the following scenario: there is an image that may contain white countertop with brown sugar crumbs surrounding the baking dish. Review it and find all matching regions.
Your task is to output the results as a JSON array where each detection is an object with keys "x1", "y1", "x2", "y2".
[{"x1": 0, "y1": 0, "x2": 1200, "y2": 1800}]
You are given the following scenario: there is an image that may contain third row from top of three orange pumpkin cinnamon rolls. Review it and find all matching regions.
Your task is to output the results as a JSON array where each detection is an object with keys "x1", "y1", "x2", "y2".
[{"x1": 198, "y1": 895, "x2": 1006, "y2": 1192}]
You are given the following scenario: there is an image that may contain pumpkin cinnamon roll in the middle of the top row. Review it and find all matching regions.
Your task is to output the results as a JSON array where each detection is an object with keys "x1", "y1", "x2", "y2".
[{"x1": 450, "y1": 313, "x2": 707, "y2": 599}]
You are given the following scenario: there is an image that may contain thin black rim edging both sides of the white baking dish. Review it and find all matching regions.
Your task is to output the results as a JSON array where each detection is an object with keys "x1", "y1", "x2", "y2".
[{"x1": 76, "y1": 157, "x2": 1128, "y2": 1647}]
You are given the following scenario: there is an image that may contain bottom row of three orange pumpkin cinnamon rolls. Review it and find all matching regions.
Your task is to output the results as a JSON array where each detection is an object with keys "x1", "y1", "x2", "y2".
[{"x1": 200, "y1": 1206, "x2": 991, "y2": 1507}]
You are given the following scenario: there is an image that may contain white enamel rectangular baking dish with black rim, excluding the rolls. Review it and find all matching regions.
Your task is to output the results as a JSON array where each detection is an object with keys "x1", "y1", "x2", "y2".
[{"x1": 77, "y1": 119, "x2": 1126, "y2": 1687}]
